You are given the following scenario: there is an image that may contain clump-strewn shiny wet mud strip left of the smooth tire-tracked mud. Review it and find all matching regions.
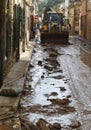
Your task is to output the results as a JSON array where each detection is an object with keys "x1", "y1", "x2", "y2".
[{"x1": 20, "y1": 41, "x2": 81, "y2": 130}]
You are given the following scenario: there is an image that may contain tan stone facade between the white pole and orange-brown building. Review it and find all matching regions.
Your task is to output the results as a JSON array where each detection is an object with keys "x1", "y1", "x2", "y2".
[{"x1": 60, "y1": 0, "x2": 81, "y2": 35}]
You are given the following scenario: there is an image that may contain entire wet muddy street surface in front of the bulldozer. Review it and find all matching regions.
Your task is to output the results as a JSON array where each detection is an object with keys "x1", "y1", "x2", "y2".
[{"x1": 19, "y1": 38, "x2": 91, "y2": 130}]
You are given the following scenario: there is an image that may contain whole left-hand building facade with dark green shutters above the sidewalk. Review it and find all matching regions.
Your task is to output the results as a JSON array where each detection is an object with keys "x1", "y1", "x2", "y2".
[{"x1": 0, "y1": 0, "x2": 37, "y2": 87}]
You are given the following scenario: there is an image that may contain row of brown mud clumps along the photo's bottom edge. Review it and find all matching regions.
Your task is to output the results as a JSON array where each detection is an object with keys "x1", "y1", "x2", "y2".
[{"x1": 21, "y1": 118, "x2": 81, "y2": 130}]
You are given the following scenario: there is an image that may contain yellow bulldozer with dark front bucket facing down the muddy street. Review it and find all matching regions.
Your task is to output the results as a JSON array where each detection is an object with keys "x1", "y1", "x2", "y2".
[{"x1": 40, "y1": 11, "x2": 69, "y2": 43}]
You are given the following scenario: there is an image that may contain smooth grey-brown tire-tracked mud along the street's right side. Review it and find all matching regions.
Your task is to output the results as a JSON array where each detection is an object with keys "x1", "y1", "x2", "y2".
[{"x1": 60, "y1": 46, "x2": 91, "y2": 130}]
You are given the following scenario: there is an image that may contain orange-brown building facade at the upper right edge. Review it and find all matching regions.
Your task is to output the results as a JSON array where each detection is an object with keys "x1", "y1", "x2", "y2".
[{"x1": 80, "y1": 0, "x2": 91, "y2": 40}]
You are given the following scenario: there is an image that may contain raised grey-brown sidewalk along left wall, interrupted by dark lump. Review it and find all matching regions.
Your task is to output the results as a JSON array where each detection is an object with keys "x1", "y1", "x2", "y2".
[{"x1": 0, "y1": 41, "x2": 35, "y2": 109}]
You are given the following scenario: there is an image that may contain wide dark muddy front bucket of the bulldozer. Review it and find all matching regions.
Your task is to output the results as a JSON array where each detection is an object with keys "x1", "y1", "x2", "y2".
[{"x1": 40, "y1": 32, "x2": 69, "y2": 44}]
